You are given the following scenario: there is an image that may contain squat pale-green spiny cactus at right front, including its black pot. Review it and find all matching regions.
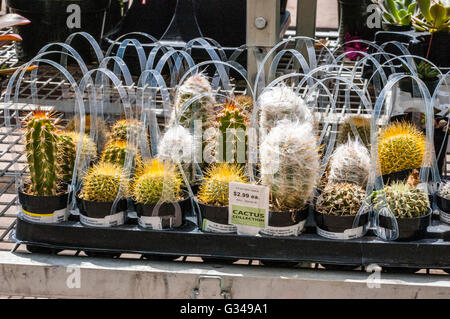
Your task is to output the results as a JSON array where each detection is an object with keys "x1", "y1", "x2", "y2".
[{"x1": 372, "y1": 182, "x2": 432, "y2": 240}]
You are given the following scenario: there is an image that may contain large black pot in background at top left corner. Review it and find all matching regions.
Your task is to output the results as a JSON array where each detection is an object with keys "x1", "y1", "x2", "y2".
[{"x1": 6, "y1": 0, "x2": 110, "y2": 62}]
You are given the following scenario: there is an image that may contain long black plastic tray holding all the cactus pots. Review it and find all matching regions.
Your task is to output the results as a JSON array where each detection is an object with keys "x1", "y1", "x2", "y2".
[{"x1": 11, "y1": 217, "x2": 450, "y2": 269}]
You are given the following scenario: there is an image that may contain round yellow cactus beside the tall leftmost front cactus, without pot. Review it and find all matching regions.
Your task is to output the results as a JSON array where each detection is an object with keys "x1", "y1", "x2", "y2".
[{"x1": 80, "y1": 162, "x2": 129, "y2": 202}]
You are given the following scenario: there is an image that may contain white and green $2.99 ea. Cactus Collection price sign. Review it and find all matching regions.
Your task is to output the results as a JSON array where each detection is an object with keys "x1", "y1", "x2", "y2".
[{"x1": 228, "y1": 182, "x2": 269, "y2": 235}]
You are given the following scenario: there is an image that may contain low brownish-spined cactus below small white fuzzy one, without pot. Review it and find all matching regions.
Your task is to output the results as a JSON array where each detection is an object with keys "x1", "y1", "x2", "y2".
[{"x1": 316, "y1": 183, "x2": 366, "y2": 216}]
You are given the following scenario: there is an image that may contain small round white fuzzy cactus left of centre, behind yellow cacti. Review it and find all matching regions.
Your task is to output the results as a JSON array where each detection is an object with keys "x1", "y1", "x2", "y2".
[{"x1": 158, "y1": 125, "x2": 194, "y2": 163}]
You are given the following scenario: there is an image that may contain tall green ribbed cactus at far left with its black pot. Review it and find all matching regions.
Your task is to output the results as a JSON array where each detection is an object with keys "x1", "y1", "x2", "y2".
[{"x1": 18, "y1": 110, "x2": 68, "y2": 222}]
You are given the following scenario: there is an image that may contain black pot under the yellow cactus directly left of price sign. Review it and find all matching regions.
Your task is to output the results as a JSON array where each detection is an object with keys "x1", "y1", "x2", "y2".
[{"x1": 198, "y1": 202, "x2": 236, "y2": 233}]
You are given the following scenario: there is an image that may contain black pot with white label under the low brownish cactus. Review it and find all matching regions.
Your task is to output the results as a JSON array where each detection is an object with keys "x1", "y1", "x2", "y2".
[{"x1": 314, "y1": 211, "x2": 369, "y2": 239}]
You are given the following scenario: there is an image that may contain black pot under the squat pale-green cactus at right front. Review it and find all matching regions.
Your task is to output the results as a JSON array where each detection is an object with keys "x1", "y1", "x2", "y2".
[{"x1": 378, "y1": 209, "x2": 432, "y2": 240}]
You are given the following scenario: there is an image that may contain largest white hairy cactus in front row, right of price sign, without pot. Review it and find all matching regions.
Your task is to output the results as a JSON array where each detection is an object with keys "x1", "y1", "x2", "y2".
[{"x1": 261, "y1": 120, "x2": 320, "y2": 211}]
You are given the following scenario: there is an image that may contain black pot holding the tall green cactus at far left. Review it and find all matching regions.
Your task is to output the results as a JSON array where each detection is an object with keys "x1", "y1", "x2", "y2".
[{"x1": 18, "y1": 188, "x2": 69, "y2": 215}]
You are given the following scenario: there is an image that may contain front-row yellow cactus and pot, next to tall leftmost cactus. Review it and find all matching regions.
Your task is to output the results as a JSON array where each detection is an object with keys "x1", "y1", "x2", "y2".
[{"x1": 77, "y1": 162, "x2": 129, "y2": 227}]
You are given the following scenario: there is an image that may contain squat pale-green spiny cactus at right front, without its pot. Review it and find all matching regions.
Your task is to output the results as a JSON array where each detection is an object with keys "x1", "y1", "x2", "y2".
[{"x1": 373, "y1": 182, "x2": 429, "y2": 218}]
